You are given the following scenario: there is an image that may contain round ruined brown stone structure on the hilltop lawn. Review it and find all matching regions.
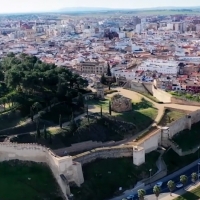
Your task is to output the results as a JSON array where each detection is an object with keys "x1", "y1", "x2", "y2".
[{"x1": 111, "y1": 94, "x2": 132, "y2": 112}]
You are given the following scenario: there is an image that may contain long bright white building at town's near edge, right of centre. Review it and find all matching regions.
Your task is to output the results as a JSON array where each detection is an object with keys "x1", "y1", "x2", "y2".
[{"x1": 138, "y1": 60, "x2": 179, "y2": 74}]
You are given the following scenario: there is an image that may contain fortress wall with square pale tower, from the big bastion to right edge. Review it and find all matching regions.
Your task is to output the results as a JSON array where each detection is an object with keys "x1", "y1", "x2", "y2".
[{"x1": 73, "y1": 110, "x2": 200, "y2": 165}]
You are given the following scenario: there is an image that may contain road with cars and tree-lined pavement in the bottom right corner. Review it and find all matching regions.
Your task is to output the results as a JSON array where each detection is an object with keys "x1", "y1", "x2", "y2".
[{"x1": 112, "y1": 161, "x2": 198, "y2": 200}]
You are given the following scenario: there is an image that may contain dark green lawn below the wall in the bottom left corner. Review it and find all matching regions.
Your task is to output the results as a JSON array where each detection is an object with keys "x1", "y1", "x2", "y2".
[{"x1": 0, "y1": 161, "x2": 62, "y2": 200}]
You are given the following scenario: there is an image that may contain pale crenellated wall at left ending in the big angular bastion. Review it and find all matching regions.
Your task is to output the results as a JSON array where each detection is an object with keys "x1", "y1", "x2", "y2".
[{"x1": 0, "y1": 142, "x2": 84, "y2": 199}]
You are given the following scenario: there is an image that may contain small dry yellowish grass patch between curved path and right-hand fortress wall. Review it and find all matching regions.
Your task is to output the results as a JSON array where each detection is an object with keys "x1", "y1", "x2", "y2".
[{"x1": 159, "y1": 109, "x2": 187, "y2": 126}]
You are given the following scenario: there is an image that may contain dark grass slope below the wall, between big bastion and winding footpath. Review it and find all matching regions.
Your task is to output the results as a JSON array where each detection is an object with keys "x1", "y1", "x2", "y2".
[{"x1": 71, "y1": 152, "x2": 159, "y2": 200}]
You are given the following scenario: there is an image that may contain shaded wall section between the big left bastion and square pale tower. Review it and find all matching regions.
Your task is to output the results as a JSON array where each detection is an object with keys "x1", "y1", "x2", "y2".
[{"x1": 73, "y1": 145, "x2": 133, "y2": 165}]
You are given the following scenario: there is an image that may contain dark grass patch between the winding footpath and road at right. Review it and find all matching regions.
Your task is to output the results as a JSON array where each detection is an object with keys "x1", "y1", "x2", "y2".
[{"x1": 163, "y1": 149, "x2": 198, "y2": 174}]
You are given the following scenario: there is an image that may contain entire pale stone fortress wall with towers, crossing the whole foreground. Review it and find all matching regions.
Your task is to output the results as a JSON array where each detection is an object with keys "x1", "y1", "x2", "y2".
[{"x1": 0, "y1": 110, "x2": 200, "y2": 199}]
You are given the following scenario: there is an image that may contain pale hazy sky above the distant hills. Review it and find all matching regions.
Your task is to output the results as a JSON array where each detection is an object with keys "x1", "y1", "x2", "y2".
[{"x1": 0, "y1": 0, "x2": 200, "y2": 13}]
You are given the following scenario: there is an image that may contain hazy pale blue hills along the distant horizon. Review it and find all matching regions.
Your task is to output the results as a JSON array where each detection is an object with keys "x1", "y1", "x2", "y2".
[{"x1": 57, "y1": 6, "x2": 200, "y2": 12}]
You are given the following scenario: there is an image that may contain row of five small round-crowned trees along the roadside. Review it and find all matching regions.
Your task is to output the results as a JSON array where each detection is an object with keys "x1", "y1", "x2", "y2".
[{"x1": 138, "y1": 172, "x2": 198, "y2": 200}]
